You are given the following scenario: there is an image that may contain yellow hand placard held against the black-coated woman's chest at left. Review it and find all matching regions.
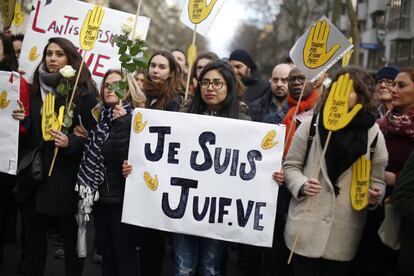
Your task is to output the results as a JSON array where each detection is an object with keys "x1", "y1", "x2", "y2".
[{"x1": 42, "y1": 93, "x2": 65, "y2": 141}]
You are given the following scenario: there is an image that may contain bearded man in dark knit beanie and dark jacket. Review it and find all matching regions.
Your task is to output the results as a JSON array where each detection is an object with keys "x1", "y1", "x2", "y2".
[{"x1": 229, "y1": 49, "x2": 269, "y2": 103}]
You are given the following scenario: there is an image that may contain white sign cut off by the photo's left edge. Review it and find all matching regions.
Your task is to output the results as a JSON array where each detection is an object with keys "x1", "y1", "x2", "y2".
[{"x1": 0, "y1": 71, "x2": 20, "y2": 175}]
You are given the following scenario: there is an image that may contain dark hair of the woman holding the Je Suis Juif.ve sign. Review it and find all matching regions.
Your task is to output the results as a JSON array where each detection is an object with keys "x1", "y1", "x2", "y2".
[{"x1": 188, "y1": 61, "x2": 239, "y2": 119}]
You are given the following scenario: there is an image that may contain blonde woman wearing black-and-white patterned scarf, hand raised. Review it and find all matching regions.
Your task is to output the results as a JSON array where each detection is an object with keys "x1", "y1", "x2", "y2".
[{"x1": 78, "y1": 70, "x2": 145, "y2": 276}]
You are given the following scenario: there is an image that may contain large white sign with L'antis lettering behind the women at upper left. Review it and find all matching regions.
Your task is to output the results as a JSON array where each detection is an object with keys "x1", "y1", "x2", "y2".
[{"x1": 19, "y1": 0, "x2": 150, "y2": 85}]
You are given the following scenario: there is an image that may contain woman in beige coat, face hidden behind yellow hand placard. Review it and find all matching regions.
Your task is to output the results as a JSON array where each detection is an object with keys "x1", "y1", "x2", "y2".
[{"x1": 284, "y1": 66, "x2": 388, "y2": 276}]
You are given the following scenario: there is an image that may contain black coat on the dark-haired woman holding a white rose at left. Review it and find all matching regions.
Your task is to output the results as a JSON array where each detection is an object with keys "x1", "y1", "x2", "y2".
[{"x1": 17, "y1": 87, "x2": 98, "y2": 216}]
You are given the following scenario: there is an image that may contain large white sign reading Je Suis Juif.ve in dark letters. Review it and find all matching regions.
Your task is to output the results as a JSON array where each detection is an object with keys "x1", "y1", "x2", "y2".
[{"x1": 122, "y1": 109, "x2": 285, "y2": 247}]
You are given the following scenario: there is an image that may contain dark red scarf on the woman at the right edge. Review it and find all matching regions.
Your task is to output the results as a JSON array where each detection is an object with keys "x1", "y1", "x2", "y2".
[{"x1": 378, "y1": 108, "x2": 414, "y2": 141}]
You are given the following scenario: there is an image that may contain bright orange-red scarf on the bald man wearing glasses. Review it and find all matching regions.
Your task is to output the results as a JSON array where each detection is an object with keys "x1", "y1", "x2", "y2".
[{"x1": 282, "y1": 90, "x2": 319, "y2": 157}]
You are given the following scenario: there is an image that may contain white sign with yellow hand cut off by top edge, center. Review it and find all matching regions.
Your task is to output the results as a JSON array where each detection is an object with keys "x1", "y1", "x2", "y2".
[{"x1": 180, "y1": 0, "x2": 224, "y2": 36}]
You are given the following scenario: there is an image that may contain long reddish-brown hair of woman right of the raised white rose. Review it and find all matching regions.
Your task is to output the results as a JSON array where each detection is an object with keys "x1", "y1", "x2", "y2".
[{"x1": 144, "y1": 51, "x2": 181, "y2": 110}]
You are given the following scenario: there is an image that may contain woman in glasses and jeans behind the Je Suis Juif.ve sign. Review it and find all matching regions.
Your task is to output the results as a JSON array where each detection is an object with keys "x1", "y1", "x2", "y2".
[{"x1": 172, "y1": 61, "x2": 250, "y2": 276}]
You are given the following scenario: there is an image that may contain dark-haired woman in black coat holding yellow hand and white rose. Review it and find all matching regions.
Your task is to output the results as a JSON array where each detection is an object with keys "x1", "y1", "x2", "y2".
[{"x1": 22, "y1": 37, "x2": 98, "y2": 276}]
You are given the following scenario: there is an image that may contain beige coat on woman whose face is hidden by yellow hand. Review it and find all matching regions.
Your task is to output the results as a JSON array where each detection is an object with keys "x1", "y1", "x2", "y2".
[{"x1": 284, "y1": 116, "x2": 388, "y2": 261}]
